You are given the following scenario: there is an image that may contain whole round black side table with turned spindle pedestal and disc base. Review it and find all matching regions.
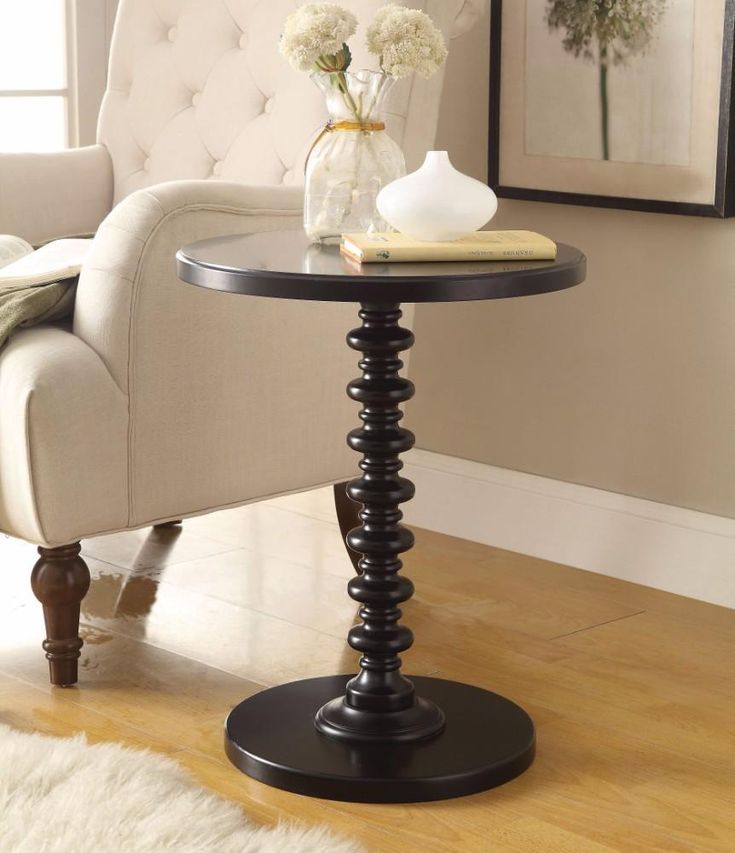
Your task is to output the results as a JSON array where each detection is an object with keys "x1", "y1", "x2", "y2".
[{"x1": 177, "y1": 225, "x2": 586, "y2": 803}]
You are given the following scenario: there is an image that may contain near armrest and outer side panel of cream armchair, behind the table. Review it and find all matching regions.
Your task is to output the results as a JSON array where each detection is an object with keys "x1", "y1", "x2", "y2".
[{"x1": 74, "y1": 181, "x2": 356, "y2": 526}]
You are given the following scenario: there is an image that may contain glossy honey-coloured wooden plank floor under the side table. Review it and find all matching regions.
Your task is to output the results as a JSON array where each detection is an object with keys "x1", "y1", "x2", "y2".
[{"x1": 0, "y1": 490, "x2": 735, "y2": 853}]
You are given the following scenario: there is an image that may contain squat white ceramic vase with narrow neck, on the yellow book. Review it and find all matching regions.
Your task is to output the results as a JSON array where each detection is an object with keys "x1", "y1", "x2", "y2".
[{"x1": 377, "y1": 151, "x2": 498, "y2": 242}]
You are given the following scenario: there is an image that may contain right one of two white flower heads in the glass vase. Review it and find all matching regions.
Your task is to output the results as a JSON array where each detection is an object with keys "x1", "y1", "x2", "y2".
[{"x1": 367, "y1": 4, "x2": 447, "y2": 77}]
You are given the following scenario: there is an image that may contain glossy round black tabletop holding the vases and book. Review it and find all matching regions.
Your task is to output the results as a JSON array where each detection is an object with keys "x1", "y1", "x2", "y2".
[{"x1": 176, "y1": 231, "x2": 587, "y2": 304}]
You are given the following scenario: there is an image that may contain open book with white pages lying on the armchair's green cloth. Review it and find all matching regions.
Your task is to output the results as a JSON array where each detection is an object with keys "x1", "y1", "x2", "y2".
[{"x1": 0, "y1": 234, "x2": 92, "y2": 291}]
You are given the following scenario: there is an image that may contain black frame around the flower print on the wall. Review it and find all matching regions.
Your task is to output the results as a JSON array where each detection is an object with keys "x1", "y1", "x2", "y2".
[{"x1": 488, "y1": 0, "x2": 735, "y2": 219}]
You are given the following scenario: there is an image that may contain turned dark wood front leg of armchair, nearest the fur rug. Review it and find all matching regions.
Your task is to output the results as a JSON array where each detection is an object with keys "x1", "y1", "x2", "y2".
[{"x1": 31, "y1": 542, "x2": 89, "y2": 687}]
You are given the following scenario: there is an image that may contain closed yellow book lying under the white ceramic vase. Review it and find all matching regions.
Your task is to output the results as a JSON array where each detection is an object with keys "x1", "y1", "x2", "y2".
[{"x1": 340, "y1": 231, "x2": 556, "y2": 264}]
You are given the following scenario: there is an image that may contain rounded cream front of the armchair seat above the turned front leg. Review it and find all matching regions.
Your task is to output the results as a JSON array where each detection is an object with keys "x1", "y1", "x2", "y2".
[{"x1": 0, "y1": 326, "x2": 128, "y2": 547}]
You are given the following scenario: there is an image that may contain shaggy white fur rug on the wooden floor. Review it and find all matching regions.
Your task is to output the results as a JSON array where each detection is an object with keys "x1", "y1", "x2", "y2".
[{"x1": 0, "y1": 725, "x2": 362, "y2": 853}]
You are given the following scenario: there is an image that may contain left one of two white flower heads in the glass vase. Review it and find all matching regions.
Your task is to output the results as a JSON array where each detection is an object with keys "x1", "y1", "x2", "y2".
[{"x1": 279, "y1": 3, "x2": 357, "y2": 71}]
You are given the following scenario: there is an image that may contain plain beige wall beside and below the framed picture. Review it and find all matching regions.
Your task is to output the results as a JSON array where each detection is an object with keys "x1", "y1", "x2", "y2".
[{"x1": 416, "y1": 8, "x2": 735, "y2": 517}]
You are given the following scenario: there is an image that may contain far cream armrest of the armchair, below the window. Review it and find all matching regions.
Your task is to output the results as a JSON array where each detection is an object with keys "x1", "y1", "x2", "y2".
[{"x1": 0, "y1": 145, "x2": 112, "y2": 245}]
